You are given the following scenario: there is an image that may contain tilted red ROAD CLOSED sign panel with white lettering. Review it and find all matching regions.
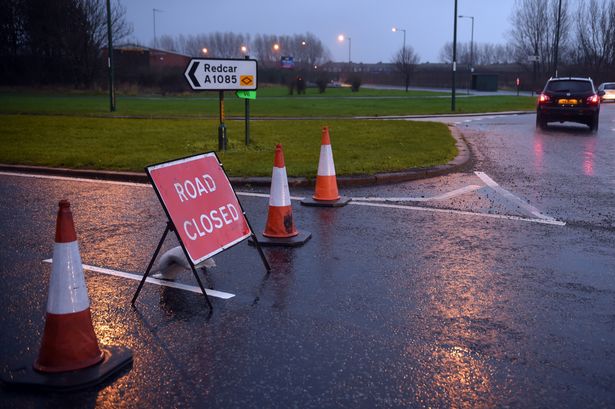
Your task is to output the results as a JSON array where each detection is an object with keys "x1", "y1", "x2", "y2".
[{"x1": 146, "y1": 152, "x2": 252, "y2": 265}]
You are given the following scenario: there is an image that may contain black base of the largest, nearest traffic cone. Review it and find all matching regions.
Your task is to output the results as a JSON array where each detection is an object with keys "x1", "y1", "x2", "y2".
[{"x1": 0, "y1": 346, "x2": 132, "y2": 392}]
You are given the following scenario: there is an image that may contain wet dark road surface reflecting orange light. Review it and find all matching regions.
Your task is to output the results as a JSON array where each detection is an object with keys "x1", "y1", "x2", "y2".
[{"x1": 0, "y1": 104, "x2": 615, "y2": 408}]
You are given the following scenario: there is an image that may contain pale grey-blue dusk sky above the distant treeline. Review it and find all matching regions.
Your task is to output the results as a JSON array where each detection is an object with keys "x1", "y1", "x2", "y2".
[{"x1": 125, "y1": 0, "x2": 514, "y2": 63}]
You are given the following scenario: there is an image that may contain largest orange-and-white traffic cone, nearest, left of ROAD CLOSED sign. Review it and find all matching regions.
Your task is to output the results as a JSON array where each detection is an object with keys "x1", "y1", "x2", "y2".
[{"x1": 3, "y1": 200, "x2": 132, "y2": 390}]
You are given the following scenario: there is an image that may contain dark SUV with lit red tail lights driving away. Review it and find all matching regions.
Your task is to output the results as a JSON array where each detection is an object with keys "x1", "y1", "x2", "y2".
[{"x1": 536, "y1": 77, "x2": 604, "y2": 132}]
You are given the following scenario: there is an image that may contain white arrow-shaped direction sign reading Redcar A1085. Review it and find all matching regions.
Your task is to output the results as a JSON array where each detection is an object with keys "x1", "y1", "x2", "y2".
[{"x1": 184, "y1": 58, "x2": 258, "y2": 91}]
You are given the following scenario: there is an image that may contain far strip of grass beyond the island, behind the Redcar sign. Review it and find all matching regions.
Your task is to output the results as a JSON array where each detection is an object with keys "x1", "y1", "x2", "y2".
[{"x1": 0, "y1": 87, "x2": 535, "y2": 118}]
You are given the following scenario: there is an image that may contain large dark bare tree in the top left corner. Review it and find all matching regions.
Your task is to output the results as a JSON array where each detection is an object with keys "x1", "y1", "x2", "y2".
[{"x1": 0, "y1": 0, "x2": 132, "y2": 86}]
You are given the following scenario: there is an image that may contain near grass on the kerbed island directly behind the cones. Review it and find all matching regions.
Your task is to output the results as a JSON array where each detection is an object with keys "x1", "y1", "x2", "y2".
[{"x1": 0, "y1": 115, "x2": 457, "y2": 177}]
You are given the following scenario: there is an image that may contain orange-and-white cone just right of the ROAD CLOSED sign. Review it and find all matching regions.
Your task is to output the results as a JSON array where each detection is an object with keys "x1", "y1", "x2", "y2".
[{"x1": 250, "y1": 144, "x2": 312, "y2": 247}]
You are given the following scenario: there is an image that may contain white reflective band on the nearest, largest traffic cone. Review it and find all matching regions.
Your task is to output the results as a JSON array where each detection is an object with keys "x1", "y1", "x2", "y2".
[{"x1": 47, "y1": 241, "x2": 90, "y2": 314}]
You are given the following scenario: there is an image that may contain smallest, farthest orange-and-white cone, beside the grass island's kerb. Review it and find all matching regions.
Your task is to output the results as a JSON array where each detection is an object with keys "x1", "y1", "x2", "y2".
[{"x1": 301, "y1": 126, "x2": 350, "y2": 207}]
